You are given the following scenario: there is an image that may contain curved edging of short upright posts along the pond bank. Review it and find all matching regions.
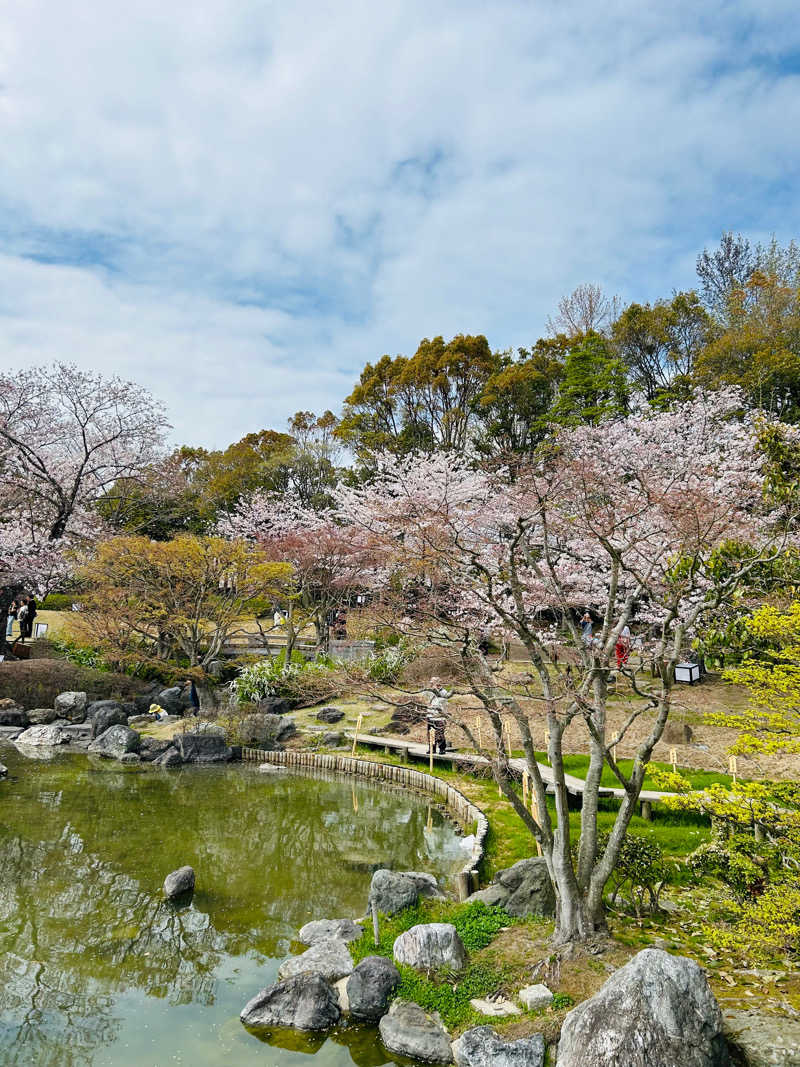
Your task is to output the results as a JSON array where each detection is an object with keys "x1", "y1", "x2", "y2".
[{"x1": 242, "y1": 748, "x2": 489, "y2": 899}]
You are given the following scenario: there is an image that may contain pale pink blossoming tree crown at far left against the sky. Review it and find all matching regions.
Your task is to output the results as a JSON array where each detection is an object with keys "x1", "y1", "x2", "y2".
[{"x1": 0, "y1": 363, "x2": 167, "y2": 540}]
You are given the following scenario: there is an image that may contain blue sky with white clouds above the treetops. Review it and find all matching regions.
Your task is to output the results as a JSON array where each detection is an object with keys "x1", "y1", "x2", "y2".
[{"x1": 0, "y1": 0, "x2": 800, "y2": 447}]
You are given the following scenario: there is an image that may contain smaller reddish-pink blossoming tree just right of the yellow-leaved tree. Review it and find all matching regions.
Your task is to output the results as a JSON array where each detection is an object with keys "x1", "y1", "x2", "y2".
[{"x1": 220, "y1": 493, "x2": 369, "y2": 664}]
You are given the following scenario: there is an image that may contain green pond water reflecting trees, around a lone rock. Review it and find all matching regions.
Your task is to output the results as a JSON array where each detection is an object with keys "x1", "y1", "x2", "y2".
[{"x1": 0, "y1": 745, "x2": 464, "y2": 1067}]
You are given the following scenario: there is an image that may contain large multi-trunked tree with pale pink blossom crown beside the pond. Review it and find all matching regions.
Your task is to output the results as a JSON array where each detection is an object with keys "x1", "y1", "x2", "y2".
[{"x1": 337, "y1": 396, "x2": 787, "y2": 943}]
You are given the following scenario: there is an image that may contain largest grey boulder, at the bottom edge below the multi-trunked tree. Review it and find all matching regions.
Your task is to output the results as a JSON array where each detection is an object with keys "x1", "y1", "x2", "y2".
[{"x1": 558, "y1": 949, "x2": 731, "y2": 1067}]
